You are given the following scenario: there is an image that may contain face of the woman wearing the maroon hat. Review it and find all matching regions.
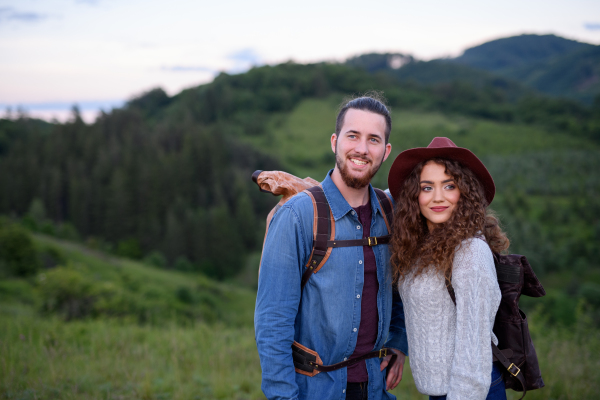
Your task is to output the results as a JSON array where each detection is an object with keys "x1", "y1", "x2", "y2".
[{"x1": 419, "y1": 161, "x2": 460, "y2": 231}]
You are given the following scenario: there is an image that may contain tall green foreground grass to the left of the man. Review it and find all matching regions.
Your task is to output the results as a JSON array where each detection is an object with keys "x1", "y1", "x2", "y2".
[{"x1": 0, "y1": 315, "x2": 262, "y2": 400}]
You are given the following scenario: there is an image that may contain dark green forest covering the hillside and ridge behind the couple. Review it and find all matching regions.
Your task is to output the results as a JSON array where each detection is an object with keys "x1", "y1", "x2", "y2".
[{"x1": 0, "y1": 63, "x2": 600, "y2": 278}]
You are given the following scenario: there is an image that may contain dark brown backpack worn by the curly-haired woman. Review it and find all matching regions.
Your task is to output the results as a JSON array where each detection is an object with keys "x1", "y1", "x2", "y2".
[{"x1": 446, "y1": 242, "x2": 546, "y2": 399}]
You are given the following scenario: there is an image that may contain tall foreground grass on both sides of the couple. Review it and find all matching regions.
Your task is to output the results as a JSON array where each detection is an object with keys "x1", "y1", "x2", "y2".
[{"x1": 0, "y1": 305, "x2": 600, "y2": 400}]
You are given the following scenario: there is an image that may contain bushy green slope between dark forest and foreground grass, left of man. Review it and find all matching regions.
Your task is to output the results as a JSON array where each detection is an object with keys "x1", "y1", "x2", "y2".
[{"x1": 11, "y1": 235, "x2": 254, "y2": 326}]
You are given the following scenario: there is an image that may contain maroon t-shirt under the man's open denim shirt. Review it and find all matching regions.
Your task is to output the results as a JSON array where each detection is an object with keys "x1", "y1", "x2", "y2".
[{"x1": 348, "y1": 202, "x2": 379, "y2": 382}]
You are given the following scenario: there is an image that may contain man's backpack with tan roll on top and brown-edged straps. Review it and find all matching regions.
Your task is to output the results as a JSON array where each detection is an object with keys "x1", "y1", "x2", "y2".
[{"x1": 252, "y1": 170, "x2": 396, "y2": 377}]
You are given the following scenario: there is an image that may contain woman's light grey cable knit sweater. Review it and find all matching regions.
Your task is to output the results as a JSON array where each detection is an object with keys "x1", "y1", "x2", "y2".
[{"x1": 398, "y1": 238, "x2": 501, "y2": 400}]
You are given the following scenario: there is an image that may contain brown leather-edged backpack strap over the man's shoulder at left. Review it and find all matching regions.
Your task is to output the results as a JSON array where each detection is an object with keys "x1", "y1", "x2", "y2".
[{"x1": 300, "y1": 186, "x2": 335, "y2": 290}]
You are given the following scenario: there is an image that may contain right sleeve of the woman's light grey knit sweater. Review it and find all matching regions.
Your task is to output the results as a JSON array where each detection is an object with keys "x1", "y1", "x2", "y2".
[{"x1": 447, "y1": 239, "x2": 500, "y2": 400}]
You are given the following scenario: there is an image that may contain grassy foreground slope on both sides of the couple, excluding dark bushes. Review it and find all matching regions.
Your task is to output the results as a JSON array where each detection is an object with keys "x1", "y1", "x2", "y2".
[{"x1": 0, "y1": 228, "x2": 600, "y2": 400}]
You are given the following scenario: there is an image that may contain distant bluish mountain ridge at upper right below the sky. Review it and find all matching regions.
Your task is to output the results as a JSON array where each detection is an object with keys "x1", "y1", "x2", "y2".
[{"x1": 346, "y1": 34, "x2": 600, "y2": 104}]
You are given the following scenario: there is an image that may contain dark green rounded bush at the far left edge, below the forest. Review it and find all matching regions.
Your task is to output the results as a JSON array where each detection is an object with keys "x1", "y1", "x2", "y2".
[{"x1": 0, "y1": 225, "x2": 40, "y2": 276}]
